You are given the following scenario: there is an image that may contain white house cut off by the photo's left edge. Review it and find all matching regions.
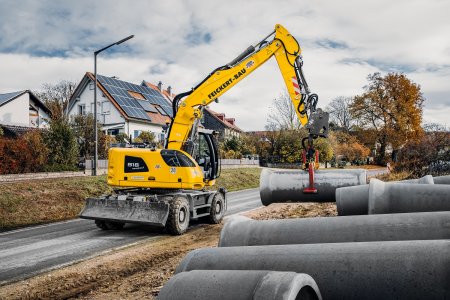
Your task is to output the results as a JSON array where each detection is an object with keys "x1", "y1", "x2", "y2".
[{"x1": 0, "y1": 90, "x2": 50, "y2": 128}]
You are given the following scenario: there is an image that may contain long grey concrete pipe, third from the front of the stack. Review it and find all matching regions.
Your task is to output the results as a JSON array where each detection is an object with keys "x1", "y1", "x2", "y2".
[{"x1": 219, "y1": 211, "x2": 450, "y2": 247}]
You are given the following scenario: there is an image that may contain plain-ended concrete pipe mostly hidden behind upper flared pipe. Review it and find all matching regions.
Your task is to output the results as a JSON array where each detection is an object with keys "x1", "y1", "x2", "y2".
[{"x1": 336, "y1": 175, "x2": 434, "y2": 216}]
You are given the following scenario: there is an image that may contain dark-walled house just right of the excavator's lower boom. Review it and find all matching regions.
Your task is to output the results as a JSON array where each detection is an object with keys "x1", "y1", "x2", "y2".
[{"x1": 201, "y1": 107, "x2": 243, "y2": 140}]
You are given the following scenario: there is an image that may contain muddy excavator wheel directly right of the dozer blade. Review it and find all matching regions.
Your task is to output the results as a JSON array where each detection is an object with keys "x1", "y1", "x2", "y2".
[{"x1": 166, "y1": 196, "x2": 191, "y2": 235}]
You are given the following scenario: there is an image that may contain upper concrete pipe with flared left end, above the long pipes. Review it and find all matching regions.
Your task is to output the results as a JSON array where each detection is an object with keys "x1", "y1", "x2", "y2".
[{"x1": 369, "y1": 179, "x2": 450, "y2": 214}]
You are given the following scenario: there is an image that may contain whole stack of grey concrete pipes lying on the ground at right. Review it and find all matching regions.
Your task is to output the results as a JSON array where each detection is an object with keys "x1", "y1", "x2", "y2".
[{"x1": 159, "y1": 176, "x2": 450, "y2": 299}]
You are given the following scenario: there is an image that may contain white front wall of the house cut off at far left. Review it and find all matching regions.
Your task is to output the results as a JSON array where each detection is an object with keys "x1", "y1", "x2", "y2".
[{"x1": 0, "y1": 93, "x2": 30, "y2": 127}]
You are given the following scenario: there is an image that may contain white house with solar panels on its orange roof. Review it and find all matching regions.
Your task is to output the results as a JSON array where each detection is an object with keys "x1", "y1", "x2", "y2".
[{"x1": 68, "y1": 72, "x2": 172, "y2": 141}]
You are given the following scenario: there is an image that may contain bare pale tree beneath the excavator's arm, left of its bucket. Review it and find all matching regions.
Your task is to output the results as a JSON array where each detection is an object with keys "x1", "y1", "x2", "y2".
[{"x1": 267, "y1": 90, "x2": 301, "y2": 130}]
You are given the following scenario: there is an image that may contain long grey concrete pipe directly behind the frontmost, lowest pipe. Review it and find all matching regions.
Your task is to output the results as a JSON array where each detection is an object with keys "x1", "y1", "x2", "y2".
[{"x1": 175, "y1": 240, "x2": 450, "y2": 300}]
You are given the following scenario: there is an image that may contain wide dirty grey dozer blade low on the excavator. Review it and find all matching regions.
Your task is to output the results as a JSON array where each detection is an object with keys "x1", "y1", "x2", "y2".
[{"x1": 80, "y1": 198, "x2": 169, "y2": 227}]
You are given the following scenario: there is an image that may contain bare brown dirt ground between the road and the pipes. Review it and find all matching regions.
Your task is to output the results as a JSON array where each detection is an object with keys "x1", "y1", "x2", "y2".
[{"x1": 0, "y1": 203, "x2": 336, "y2": 299}]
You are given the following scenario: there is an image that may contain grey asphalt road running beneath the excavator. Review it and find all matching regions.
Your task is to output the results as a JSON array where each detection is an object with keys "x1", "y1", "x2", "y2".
[{"x1": 0, "y1": 189, "x2": 261, "y2": 285}]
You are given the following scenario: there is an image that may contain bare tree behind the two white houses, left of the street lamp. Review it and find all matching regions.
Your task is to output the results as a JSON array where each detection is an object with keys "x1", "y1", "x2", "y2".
[{"x1": 35, "y1": 80, "x2": 77, "y2": 122}]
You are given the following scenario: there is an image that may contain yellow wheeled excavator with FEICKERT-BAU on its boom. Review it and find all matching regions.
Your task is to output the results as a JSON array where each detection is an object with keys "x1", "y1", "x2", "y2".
[{"x1": 80, "y1": 25, "x2": 328, "y2": 234}]
